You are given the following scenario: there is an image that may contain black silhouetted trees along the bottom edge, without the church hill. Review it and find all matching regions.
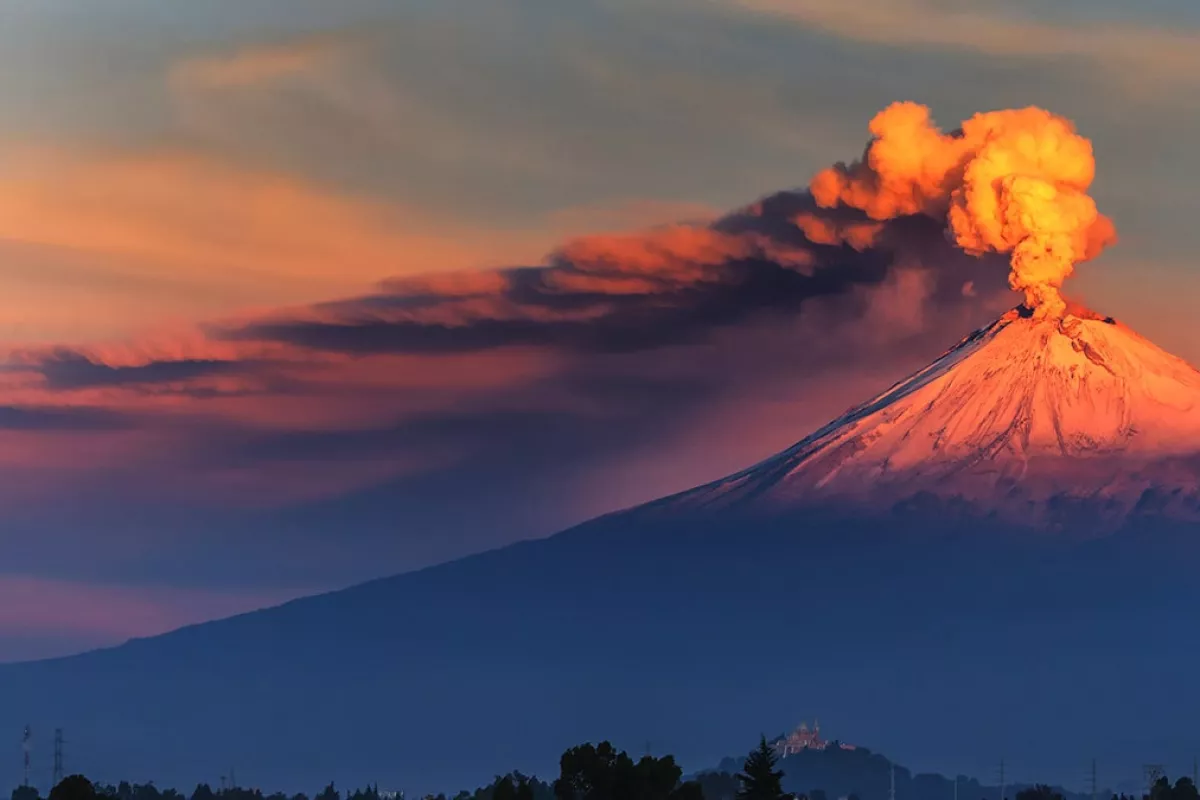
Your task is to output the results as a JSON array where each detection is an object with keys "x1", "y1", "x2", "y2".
[{"x1": 12, "y1": 739, "x2": 1200, "y2": 800}]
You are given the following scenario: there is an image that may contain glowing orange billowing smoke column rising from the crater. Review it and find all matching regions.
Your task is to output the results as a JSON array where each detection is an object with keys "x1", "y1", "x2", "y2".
[{"x1": 810, "y1": 103, "x2": 1116, "y2": 318}]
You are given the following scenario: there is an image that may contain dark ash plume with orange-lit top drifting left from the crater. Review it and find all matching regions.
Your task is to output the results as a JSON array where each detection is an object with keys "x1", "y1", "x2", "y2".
[{"x1": 218, "y1": 192, "x2": 1006, "y2": 354}]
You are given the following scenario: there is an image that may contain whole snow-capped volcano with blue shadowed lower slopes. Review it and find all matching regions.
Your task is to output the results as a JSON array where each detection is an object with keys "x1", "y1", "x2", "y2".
[{"x1": 0, "y1": 311, "x2": 1200, "y2": 792}]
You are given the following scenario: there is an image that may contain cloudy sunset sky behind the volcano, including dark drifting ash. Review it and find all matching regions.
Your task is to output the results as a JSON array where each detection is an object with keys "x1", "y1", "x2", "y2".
[{"x1": 0, "y1": 0, "x2": 1200, "y2": 660}]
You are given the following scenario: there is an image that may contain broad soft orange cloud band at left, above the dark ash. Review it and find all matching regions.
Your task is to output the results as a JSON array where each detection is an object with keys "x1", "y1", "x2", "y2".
[{"x1": 0, "y1": 149, "x2": 571, "y2": 342}]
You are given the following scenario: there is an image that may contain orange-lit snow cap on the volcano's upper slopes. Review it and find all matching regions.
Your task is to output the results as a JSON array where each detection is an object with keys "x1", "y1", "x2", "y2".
[{"x1": 667, "y1": 308, "x2": 1200, "y2": 522}]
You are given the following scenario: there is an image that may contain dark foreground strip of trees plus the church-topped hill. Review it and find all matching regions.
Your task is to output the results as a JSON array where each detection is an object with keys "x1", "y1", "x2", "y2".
[{"x1": 12, "y1": 724, "x2": 1171, "y2": 800}]
